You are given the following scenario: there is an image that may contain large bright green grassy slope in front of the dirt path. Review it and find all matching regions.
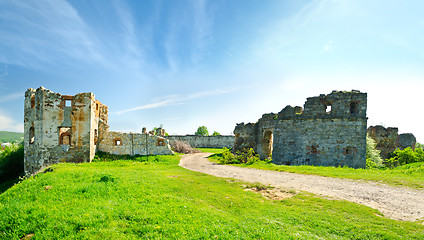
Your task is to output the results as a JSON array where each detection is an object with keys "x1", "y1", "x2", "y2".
[{"x1": 0, "y1": 156, "x2": 424, "y2": 239}]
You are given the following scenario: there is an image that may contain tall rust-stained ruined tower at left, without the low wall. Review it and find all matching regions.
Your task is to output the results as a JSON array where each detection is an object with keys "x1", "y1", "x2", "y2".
[{"x1": 24, "y1": 87, "x2": 101, "y2": 174}]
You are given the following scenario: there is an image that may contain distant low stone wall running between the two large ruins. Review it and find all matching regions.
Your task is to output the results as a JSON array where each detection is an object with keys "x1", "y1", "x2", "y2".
[{"x1": 165, "y1": 135, "x2": 235, "y2": 148}]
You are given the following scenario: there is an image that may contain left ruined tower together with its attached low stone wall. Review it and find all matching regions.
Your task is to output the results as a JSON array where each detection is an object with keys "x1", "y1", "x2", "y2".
[{"x1": 24, "y1": 87, "x2": 173, "y2": 175}]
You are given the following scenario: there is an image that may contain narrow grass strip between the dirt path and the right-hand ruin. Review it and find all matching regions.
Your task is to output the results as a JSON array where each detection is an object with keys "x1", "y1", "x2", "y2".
[{"x1": 209, "y1": 150, "x2": 424, "y2": 189}]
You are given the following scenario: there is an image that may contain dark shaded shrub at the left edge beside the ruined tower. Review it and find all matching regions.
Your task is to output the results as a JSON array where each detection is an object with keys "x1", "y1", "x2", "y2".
[{"x1": 0, "y1": 144, "x2": 24, "y2": 182}]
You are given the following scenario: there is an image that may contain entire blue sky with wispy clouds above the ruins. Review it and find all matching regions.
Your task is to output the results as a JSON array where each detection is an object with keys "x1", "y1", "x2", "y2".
[{"x1": 0, "y1": 0, "x2": 424, "y2": 142}]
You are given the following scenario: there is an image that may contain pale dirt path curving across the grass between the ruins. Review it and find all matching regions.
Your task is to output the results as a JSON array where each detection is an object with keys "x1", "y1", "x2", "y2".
[{"x1": 180, "y1": 153, "x2": 424, "y2": 221}]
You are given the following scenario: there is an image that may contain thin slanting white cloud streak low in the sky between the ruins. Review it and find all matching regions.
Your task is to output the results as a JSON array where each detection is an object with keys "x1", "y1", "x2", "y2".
[{"x1": 112, "y1": 89, "x2": 233, "y2": 115}]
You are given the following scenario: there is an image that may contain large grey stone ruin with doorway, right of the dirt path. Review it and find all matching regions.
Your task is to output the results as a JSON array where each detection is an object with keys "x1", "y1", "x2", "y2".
[{"x1": 234, "y1": 90, "x2": 367, "y2": 168}]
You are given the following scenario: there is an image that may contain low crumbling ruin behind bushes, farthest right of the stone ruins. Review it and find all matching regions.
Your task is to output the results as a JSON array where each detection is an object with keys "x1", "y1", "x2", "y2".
[{"x1": 367, "y1": 125, "x2": 417, "y2": 159}]
